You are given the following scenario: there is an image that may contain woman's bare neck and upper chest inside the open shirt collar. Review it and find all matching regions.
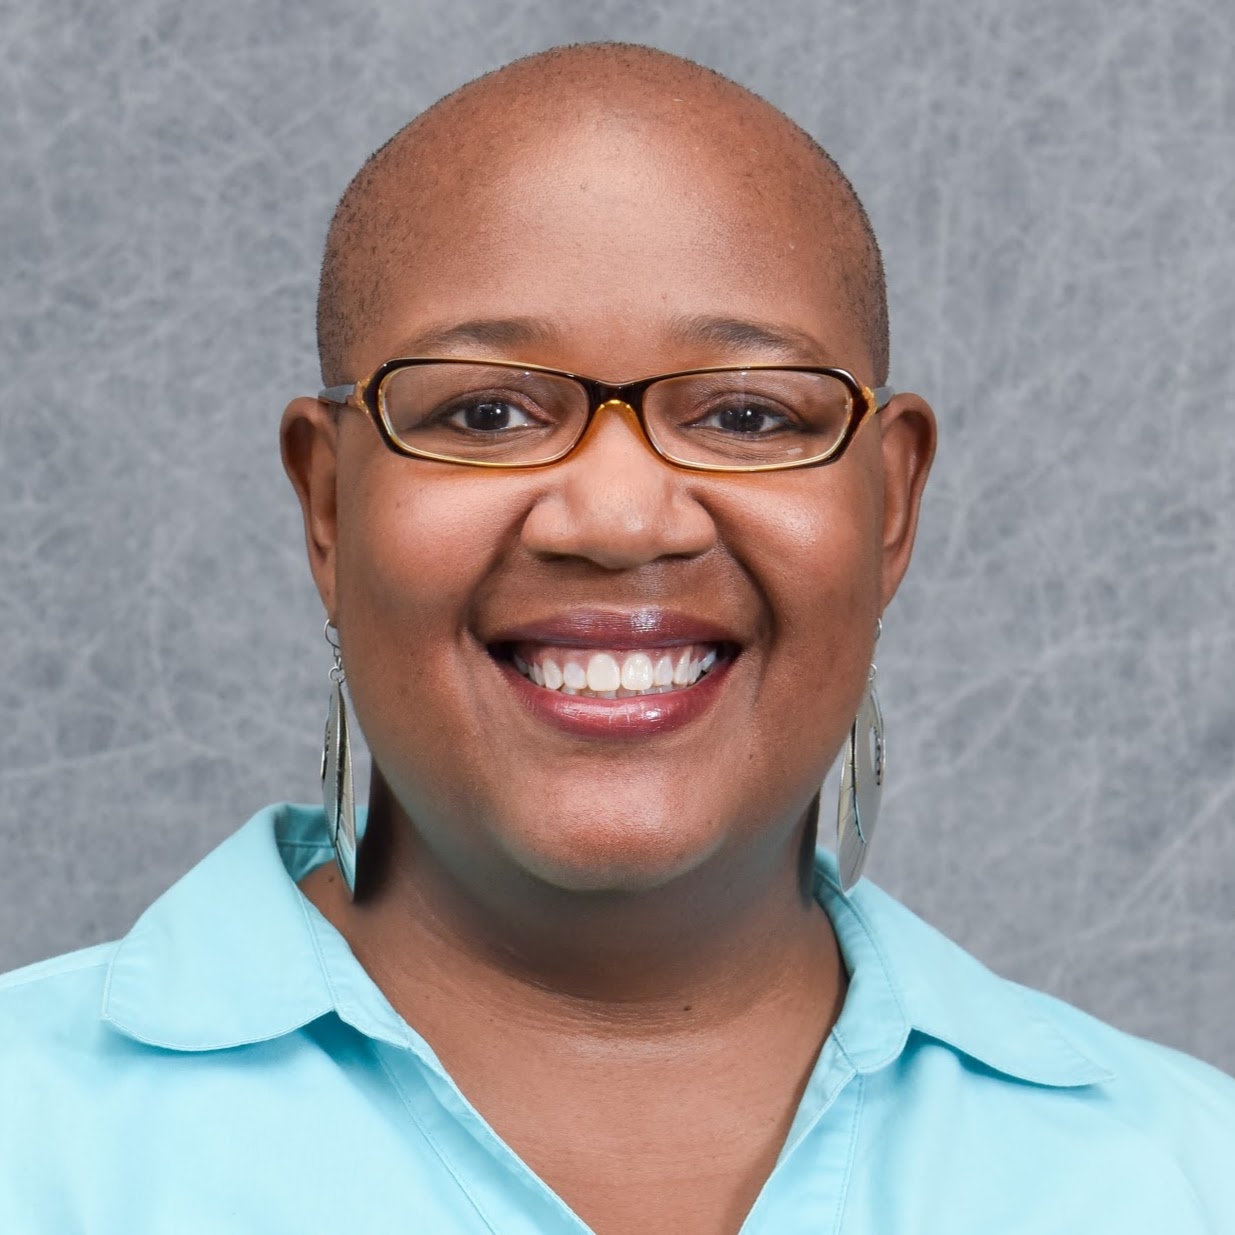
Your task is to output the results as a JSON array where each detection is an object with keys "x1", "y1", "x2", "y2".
[{"x1": 301, "y1": 765, "x2": 845, "y2": 1231}]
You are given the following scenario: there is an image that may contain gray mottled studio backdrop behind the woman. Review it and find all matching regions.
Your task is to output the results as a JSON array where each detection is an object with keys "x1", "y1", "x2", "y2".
[{"x1": 0, "y1": 0, "x2": 1235, "y2": 1070}]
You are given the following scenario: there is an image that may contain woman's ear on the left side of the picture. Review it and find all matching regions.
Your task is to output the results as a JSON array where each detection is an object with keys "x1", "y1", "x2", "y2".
[{"x1": 279, "y1": 398, "x2": 338, "y2": 621}]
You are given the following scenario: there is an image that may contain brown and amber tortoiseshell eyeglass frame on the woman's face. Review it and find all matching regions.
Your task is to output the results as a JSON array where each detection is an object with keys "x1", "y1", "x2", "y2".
[{"x1": 317, "y1": 356, "x2": 895, "y2": 472}]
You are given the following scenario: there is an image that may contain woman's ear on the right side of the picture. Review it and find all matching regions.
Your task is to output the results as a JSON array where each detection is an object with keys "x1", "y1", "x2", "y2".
[{"x1": 879, "y1": 394, "x2": 937, "y2": 608}]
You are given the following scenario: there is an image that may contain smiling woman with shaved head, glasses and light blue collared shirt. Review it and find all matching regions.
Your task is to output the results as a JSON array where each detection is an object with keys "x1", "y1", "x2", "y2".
[{"x1": 0, "y1": 47, "x2": 1235, "y2": 1235}]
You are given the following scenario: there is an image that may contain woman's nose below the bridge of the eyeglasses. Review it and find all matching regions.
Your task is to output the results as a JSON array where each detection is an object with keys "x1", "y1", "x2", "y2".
[{"x1": 522, "y1": 399, "x2": 716, "y2": 571}]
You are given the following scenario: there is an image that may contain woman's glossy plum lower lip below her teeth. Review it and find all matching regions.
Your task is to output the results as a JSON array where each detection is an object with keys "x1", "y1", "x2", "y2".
[{"x1": 496, "y1": 659, "x2": 734, "y2": 740}]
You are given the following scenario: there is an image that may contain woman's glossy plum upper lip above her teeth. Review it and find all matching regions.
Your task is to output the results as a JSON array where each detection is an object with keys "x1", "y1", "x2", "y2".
[{"x1": 484, "y1": 605, "x2": 742, "y2": 650}]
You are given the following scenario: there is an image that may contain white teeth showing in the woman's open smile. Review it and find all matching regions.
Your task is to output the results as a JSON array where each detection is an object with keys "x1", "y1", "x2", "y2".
[{"x1": 511, "y1": 643, "x2": 725, "y2": 699}]
